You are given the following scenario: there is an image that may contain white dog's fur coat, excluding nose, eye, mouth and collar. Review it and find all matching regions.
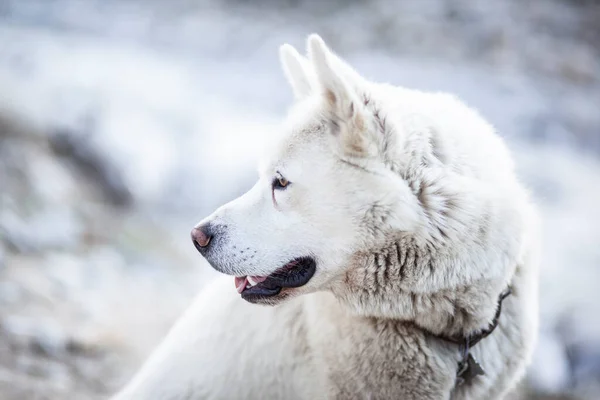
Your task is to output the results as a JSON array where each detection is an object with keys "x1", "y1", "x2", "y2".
[{"x1": 112, "y1": 35, "x2": 538, "y2": 400}]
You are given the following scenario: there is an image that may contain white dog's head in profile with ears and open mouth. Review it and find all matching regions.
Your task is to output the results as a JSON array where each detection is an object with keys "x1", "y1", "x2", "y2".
[{"x1": 192, "y1": 35, "x2": 419, "y2": 304}]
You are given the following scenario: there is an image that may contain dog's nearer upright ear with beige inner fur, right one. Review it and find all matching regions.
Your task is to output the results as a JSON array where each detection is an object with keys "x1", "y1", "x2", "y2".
[{"x1": 308, "y1": 34, "x2": 376, "y2": 157}]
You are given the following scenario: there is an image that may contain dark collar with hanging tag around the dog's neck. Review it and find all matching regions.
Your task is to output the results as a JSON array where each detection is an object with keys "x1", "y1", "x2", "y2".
[{"x1": 420, "y1": 286, "x2": 512, "y2": 387}]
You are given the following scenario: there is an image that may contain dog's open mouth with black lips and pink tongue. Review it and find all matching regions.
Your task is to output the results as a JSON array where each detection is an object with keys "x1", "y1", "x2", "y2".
[{"x1": 235, "y1": 257, "x2": 317, "y2": 302}]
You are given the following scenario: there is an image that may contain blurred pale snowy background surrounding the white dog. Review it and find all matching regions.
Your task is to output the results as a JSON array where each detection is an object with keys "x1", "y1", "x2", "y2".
[{"x1": 0, "y1": 0, "x2": 600, "y2": 400}]
